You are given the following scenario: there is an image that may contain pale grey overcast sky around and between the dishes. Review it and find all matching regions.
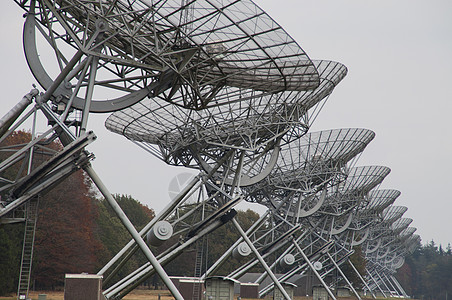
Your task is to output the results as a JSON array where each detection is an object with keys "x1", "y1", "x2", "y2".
[{"x1": 0, "y1": 0, "x2": 452, "y2": 246}]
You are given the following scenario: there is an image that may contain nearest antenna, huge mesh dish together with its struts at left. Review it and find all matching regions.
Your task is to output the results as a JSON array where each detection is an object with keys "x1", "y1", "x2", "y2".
[{"x1": 0, "y1": 0, "x2": 328, "y2": 299}]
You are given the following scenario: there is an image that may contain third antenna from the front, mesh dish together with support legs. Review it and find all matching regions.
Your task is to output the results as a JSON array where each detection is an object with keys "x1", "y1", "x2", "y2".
[{"x1": 201, "y1": 129, "x2": 374, "y2": 295}]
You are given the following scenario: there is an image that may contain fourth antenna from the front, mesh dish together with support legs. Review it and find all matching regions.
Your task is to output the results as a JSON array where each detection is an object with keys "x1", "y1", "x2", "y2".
[{"x1": 254, "y1": 166, "x2": 389, "y2": 297}]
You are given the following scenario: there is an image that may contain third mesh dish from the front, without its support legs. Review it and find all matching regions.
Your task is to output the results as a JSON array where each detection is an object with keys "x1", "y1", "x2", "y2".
[{"x1": 244, "y1": 128, "x2": 375, "y2": 217}]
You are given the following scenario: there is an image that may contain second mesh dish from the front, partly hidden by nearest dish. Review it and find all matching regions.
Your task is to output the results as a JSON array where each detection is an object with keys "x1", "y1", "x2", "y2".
[{"x1": 106, "y1": 61, "x2": 347, "y2": 185}]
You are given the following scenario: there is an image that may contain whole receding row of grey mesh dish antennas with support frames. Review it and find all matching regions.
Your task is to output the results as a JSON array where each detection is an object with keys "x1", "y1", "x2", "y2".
[{"x1": 0, "y1": 0, "x2": 420, "y2": 299}]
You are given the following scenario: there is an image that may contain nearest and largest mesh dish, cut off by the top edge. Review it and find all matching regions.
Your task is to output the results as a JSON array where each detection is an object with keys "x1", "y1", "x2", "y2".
[{"x1": 18, "y1": 0, "x2": 320, "y2": 112}]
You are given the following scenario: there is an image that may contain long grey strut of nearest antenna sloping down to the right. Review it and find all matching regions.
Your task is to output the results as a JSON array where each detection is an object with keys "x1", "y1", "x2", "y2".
[{"x1": 83, "y1": 165, "x2": 184, "y2": 300}]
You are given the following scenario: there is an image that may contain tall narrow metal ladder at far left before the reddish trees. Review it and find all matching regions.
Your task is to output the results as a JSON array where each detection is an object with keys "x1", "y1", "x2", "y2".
[{"x1": 17, "y1": 198, "x2": 39, "y2": 299}]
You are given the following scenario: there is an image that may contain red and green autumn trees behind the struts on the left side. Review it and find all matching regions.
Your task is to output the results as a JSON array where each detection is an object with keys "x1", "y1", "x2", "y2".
[{"x1": 0, "y1": 131, "x2": 259, "y2": 295}]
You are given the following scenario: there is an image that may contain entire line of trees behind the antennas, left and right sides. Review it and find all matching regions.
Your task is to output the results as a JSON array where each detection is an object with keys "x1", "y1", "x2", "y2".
[{"x1": 0, "y1": 131, "x2": 452, "y2": 299}]
